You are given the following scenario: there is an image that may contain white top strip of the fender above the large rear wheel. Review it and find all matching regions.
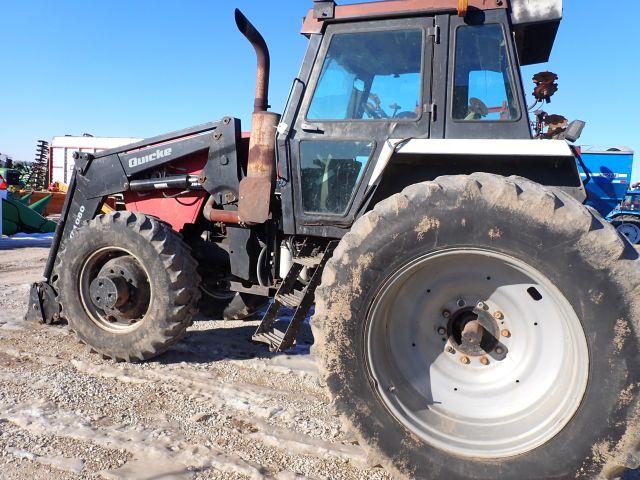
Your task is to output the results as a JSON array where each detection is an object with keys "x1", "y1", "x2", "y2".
[{"x1": 369, "y1": 139, "x2": 574, "y2": 185}]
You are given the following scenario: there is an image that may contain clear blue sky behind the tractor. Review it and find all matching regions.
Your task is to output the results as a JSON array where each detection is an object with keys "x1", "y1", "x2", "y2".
[{"x1": 0, "y1": 0, "x2": 640, "y2": 180}]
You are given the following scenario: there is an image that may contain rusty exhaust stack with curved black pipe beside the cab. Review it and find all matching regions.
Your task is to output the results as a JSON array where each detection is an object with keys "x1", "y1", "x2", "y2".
[{"x1": 235, "y1": 9, "x2": 280, "y2": 224}]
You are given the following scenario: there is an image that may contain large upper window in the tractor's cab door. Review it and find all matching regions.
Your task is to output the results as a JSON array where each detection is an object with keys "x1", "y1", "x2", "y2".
[{"x1": 307, "y1": 30, "x2": 422, "y2": 120}]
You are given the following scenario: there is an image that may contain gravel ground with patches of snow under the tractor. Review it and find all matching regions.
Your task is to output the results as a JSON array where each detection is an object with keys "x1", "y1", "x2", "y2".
[{"x1": 0, "y1": 248, "x2": 389, "y2": 480}]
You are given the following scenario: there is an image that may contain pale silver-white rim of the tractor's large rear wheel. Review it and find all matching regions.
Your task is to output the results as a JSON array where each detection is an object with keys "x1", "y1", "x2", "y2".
[{"x1": 365, "y1": 249, "x2": 589, "y2": 458}]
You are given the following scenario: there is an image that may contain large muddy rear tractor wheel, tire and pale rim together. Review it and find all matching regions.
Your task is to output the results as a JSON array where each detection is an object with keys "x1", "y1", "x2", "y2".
[{"x1": 312, "y1": 174, "x2": 640, "y2": 480}]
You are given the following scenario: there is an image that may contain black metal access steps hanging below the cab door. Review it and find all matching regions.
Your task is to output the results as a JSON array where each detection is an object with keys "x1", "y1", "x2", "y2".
[{"x1": 252, "y1": 241, "x2": 338, "y2": 352}]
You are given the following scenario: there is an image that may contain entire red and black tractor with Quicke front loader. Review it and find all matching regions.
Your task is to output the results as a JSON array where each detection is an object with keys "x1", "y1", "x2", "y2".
[{"x1": 22, "y1": 0, "x2": 640, "y2": 480}]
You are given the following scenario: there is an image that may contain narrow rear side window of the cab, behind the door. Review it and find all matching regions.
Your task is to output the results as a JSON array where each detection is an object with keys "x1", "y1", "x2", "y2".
[{"x1": 453, "y1": 24, "x2": 519, "y2": 122}]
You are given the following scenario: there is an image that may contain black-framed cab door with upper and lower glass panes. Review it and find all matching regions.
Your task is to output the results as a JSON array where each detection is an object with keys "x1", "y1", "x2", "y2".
[{"x1": 284, "y1": 17, "x2": 434, "y2": 238}]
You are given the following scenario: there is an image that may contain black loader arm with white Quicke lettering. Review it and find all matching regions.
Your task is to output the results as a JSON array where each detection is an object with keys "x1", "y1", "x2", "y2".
[{"x1": 26, "y1": 117, "x2": 244, "y2": 323}]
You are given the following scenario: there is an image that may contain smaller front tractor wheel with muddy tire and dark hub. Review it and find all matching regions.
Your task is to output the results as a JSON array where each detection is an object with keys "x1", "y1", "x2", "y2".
[{"x1": 57, "y1": 212, "x2": 200, "y2": 362}]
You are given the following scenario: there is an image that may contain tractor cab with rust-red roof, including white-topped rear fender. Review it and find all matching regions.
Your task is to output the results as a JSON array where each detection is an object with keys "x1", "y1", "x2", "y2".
[{"x1": 277, "y1": 0, "x2": 584, "y2": 237}]
